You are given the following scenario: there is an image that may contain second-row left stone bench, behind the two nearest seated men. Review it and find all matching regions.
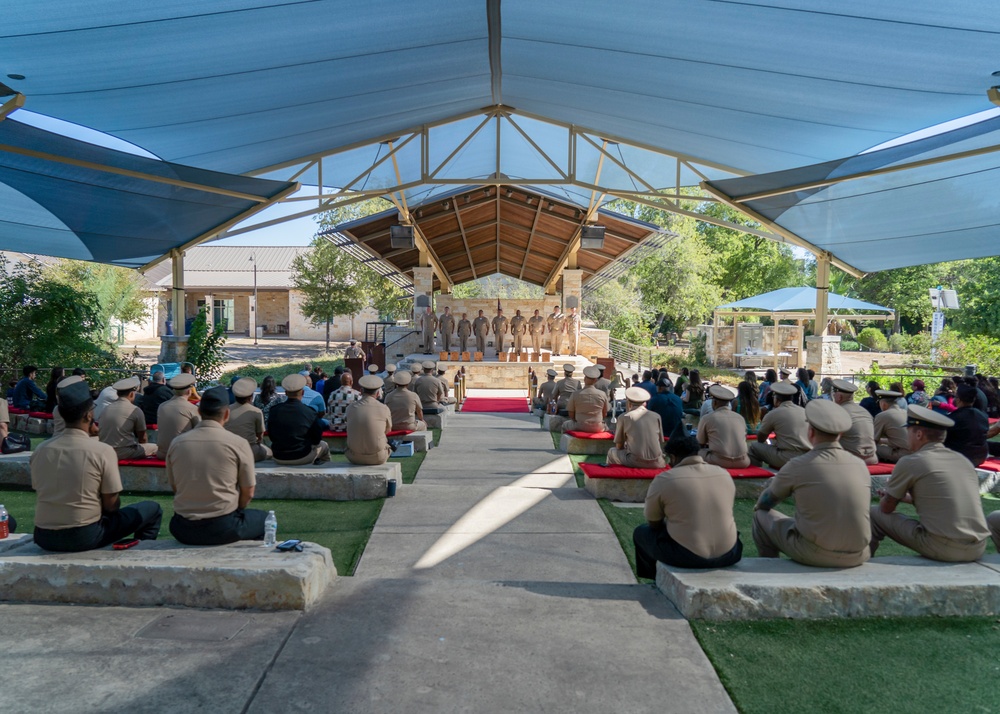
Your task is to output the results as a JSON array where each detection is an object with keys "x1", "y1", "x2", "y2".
[{"x1": 0, "y1": 453, "x2": 403, "y2": 501}]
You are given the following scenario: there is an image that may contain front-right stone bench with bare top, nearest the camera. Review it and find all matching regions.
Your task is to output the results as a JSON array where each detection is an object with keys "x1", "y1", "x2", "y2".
[{"x1": 656, "y1": 555, "x2": 1000, "y2": 620}]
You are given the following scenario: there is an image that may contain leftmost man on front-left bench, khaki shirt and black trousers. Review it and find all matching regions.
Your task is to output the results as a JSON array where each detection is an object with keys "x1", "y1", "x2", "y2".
[{"x1": 31, "y1": 379, "x2": 163, "y2": 553}]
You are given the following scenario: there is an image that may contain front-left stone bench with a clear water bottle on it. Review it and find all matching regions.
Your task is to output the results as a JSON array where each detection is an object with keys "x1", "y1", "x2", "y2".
[{"x1": 0, "y1": 536, "x2": 337, "y2": 610}]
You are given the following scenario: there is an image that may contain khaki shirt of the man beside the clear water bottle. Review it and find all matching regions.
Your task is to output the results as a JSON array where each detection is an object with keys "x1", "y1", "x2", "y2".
[{"x1": 168, "y1": 417, "x2": 257, "y2": 521}]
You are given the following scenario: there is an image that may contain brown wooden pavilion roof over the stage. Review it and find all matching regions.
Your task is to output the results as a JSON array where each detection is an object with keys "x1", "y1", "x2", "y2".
[{"x1": 328, "y1": 186, "x2": 662, "y2": 289}]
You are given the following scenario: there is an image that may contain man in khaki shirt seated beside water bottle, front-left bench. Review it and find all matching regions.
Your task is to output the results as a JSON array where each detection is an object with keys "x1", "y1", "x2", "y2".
[{"x1": 167, "y1": 379, "x2": 267, "y2": 545}]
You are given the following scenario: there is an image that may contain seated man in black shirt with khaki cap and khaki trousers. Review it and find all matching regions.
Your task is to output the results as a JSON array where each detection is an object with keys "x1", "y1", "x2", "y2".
[{"x1": 267, "y1": 374, "x2": 330, "y2": 466}]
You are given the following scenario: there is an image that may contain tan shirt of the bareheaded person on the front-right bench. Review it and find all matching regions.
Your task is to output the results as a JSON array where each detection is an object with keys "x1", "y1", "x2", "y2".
[{"x1": 644, "y1": 456, "x2": 737, "y2": 558}]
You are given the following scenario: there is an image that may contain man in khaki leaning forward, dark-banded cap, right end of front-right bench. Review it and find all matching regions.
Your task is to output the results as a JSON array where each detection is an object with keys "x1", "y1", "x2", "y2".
[{"x1": 871, "y1": 406, "x2": 990, "y2": 563}]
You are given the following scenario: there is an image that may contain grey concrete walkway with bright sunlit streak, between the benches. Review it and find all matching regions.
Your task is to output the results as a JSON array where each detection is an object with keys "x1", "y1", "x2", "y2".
[{"x1": 0, "y1": 398, "x2": 734, "y2": 714}]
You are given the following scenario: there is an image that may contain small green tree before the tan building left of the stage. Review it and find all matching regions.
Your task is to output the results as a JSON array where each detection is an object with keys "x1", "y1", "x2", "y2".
[{"x1": 292, "y1": 236, "x2": 366, "y2": 352}]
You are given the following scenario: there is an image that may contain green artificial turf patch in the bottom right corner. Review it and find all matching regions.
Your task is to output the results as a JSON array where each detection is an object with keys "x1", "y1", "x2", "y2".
[{"x1": 691, "y1": 617, "x2": 1000, "y2": 714}]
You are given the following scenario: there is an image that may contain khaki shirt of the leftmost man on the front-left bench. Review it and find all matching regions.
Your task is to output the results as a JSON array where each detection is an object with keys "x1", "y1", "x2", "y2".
[{"x1": 31, "y1": 426, "x2": 122, "y2": 531}]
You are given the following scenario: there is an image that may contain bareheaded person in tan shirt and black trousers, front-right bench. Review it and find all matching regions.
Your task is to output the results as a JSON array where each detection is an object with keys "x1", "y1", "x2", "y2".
[{"x1": 632, "y1": 436, "x2": 743, "y2": 579}]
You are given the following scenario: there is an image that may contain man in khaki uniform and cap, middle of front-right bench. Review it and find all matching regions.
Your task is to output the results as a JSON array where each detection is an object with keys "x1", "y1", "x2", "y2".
[{"x1": 753, "y1": 399, "x2": 871, "y2": 568}]
